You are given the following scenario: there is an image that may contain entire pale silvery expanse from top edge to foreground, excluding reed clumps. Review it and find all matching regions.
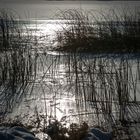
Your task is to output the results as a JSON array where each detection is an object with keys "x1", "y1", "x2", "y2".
[{"x1": 0, "y1": 1, "x2": 140, "y2": 138}]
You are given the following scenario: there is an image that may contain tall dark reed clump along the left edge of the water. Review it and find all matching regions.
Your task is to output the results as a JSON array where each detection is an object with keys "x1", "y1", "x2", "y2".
[{"x1": 0, "y1": 10, "x2": 36, "y2": 114}]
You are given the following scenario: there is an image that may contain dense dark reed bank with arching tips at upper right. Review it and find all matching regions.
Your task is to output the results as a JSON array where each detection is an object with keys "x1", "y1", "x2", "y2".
[{"x1": 57, "y1": 9, "x2": 140, "y2": 53}]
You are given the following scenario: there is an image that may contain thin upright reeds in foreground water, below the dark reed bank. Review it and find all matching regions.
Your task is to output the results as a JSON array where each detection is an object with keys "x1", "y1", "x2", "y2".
[{"x1": 64, "y1": 53, "x2": 139, "y2": 127}]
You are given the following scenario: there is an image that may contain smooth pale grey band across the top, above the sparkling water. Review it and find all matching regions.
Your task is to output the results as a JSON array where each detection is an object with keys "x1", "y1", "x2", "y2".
[{"x1": 0, "y1": 1, "x2": 140, "y2": 19}]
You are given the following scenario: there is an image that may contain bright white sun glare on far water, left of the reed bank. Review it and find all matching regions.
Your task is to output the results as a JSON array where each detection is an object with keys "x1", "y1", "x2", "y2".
[{"x1": 26, "y1": 20, "x2": 68, "y2": 49}]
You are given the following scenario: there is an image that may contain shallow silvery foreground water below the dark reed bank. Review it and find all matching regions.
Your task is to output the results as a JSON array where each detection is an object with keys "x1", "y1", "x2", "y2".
[{"x1": 6, "y1": 51, "x2": 140, "y2": 129}]
